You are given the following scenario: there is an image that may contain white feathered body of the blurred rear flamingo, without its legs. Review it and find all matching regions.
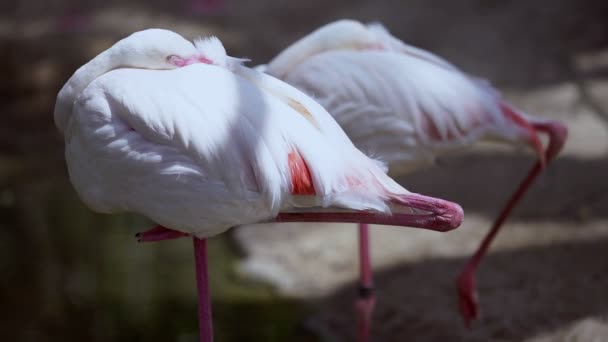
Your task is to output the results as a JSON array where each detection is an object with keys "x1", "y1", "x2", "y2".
[{"x1": 266, "y1": 22, "x2": 536, "y2": 172}]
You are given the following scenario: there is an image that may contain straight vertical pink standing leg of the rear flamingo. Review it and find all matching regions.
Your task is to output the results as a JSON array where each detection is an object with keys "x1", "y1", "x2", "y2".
[{"x1": 356, "y1": 223, "x2": 376, "y2": 342}]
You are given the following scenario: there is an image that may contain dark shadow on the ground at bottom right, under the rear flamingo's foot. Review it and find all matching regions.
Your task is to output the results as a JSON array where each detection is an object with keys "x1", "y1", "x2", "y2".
[{"x1": 309, "y1": 239, "x2": 608, "y2": 342}]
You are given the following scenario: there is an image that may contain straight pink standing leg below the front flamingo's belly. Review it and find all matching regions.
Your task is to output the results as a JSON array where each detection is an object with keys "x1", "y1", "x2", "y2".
[{"x1": 192, "y1": 237, "x2": 213, "y2": 342}]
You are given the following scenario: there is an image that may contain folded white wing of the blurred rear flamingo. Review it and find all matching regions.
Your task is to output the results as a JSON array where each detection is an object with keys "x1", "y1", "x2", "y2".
[{"x1": 285, "y1": 51, "x2": 501, "y2": 174}]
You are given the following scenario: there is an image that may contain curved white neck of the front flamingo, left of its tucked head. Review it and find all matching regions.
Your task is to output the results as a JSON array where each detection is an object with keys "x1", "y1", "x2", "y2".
[{"x1": 54, "y1": 48, "x2": 120, "y2": 133}]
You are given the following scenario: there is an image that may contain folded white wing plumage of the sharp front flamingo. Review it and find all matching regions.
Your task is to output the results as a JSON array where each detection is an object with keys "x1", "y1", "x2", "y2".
[{"x1": 66, "y1": 65, "x2": 406, "y2": 236}]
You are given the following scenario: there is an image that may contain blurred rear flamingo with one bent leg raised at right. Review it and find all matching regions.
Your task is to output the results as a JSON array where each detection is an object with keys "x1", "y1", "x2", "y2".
[{"x1": 258, "y1": 20, "x2": 567, "y2": 340}]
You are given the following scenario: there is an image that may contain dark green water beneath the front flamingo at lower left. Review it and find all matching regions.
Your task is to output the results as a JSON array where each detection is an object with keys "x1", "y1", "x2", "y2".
[{"x1": 0, "y1": 165, "x2": 313, "y2": 342}]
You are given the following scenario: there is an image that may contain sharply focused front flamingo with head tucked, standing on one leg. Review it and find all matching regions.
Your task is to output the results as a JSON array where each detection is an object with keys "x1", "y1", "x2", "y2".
[{"x1": 54, "y1": 29, "x2": 463, "y2": 342}]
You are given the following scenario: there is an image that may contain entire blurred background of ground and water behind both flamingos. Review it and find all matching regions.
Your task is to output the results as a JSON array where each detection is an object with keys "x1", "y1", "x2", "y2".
[{"x1": 0, "y1": 0, "x2": 608, "y2": 342}]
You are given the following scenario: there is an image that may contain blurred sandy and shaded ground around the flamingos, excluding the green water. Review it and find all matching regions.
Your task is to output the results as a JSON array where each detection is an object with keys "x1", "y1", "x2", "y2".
[{"x1": 0, "y1": 0, "x2": 608, "y2": 341}]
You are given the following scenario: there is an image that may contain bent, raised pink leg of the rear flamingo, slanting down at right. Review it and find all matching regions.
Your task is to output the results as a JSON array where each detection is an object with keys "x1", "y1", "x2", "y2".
[{"x1": 456, "y1": 121, "x2": 568, "y2": 327}]
